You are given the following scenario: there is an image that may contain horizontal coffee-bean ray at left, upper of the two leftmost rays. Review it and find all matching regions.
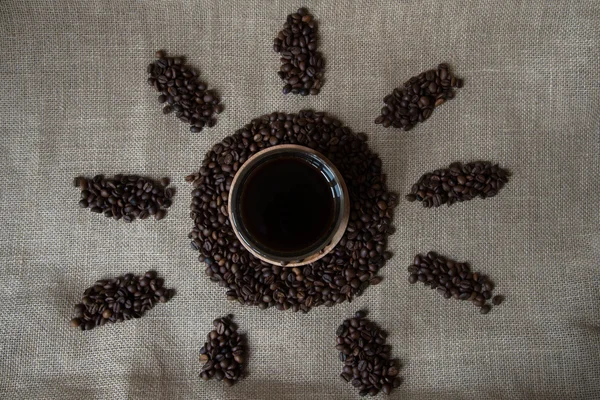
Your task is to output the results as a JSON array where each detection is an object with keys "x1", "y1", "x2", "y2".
[{"x1": 74, "y1": 175, "x2": 174, "y2": 222}]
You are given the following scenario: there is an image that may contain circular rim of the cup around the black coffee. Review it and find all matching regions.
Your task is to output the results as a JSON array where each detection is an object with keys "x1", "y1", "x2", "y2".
[{"x1": 227, "y1": 144, "x2": 350, "y2": 267}]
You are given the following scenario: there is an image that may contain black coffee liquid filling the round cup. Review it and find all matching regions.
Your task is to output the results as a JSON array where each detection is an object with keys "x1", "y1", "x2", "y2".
[{"x1": 240, "y1": 156, "x2": 336, "y2": 254}]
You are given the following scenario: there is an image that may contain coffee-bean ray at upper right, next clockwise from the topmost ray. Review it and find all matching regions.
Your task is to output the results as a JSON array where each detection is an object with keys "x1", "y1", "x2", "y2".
[{"x1": 375, "y1": 64, "x2": 463, "y2": 131}]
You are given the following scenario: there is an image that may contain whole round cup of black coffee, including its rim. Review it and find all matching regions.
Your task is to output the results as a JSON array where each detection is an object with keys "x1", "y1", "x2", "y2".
[{"x1": 228, "y1": 145, "x2": 350, "y2": 267}]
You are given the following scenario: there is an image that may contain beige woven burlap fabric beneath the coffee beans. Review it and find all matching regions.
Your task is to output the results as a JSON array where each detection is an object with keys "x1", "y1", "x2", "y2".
[{"x1": 0, "y1": 0, "x2": 600, "y2": 400}]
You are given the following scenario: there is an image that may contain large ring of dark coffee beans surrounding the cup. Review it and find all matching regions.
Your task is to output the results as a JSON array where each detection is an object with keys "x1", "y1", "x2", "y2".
[{"x1": 186, "y1": 110, "x2": 397, "y2": 312}]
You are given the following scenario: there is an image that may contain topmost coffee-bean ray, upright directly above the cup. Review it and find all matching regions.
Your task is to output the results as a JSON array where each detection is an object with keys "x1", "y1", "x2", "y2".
[{"x1": 273, "y1": 8, "x2": 323, "y2": 96}]
